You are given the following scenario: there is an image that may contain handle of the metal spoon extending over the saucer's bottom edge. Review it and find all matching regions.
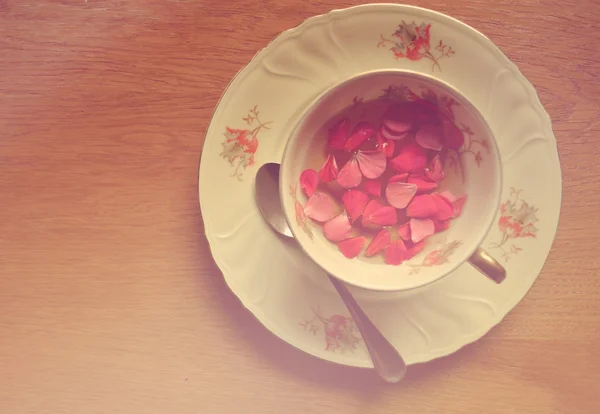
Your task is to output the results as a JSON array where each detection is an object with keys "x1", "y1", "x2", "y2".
[{"x1": 327, "y1": 274, "x2": 406, "y2": 383}]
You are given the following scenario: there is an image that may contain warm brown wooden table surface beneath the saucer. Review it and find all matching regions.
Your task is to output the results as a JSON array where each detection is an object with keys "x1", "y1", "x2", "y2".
[{"x1": 0, "y1": 0, "x2": 600, "y2": 414}]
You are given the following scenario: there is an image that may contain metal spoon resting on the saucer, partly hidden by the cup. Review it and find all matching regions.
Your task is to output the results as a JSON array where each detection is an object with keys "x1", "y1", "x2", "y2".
[{"x1": 255, "y1": 163, "x2": 406, "y2": 382}]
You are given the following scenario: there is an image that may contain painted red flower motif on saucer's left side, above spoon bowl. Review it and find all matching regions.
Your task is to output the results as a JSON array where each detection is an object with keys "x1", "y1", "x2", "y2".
[{"x1": 220, "y1": 106, "x2": 270, "y2": 181}]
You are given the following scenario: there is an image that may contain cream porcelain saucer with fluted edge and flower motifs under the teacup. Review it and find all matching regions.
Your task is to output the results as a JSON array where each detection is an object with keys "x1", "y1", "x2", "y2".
[{"x1": 199, "y1": 4, "x2": 562, "y2": 368}]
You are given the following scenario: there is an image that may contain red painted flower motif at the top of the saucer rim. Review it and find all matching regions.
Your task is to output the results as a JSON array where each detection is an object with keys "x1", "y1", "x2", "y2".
[{"x1": 377, "y1": 20, "x2": 455, "y2": 71}]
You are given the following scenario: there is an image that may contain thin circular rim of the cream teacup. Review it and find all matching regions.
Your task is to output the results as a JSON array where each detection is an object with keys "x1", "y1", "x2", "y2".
[{"x1": 279, "y1": 69, "x2": 504, "y2": 292}]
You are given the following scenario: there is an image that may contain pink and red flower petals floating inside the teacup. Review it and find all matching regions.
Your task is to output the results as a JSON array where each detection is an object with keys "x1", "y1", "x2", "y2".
[{"x1": 300, "y1": 100, "x2": 466, "y2": 265}]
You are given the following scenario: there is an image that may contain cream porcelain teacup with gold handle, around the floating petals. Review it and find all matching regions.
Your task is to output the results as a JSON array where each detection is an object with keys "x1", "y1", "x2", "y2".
[{"x1": 280, "y1": 70, "x2": 505, "y2": 291}]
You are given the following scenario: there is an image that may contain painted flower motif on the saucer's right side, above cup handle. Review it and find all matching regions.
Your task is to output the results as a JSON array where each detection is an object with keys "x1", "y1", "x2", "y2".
[{"x1": 490, "y1": 188, "x2": 538, "y2": 262}]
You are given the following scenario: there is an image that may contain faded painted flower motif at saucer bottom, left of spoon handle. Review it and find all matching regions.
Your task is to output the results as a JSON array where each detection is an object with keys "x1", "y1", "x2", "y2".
[{"x1": 300, "y1": 308, "x2": 362, "y2": 352}]
